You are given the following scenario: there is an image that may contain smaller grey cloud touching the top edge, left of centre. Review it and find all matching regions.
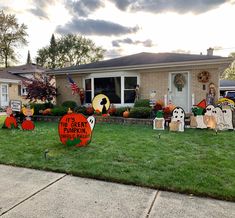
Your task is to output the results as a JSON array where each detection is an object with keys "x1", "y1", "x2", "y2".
[{"x1": 65, "y1": 0, "x2": 105, "y2": 17}]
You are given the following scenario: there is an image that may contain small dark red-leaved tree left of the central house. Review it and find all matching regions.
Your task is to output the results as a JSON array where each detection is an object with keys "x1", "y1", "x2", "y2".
[{"x1": 23, "y1": 75, "x2": 57, "y2": 102}]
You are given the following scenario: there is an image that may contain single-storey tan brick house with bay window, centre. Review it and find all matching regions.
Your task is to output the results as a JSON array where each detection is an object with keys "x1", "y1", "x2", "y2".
[{"x1": 49, "y1": 49, "x2": 233, "y2": 112}]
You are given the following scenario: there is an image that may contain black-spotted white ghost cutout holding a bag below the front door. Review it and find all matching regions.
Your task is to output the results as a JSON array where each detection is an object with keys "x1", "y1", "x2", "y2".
[{"x1": 169, "y1": 107, "x2": 185, "y2": 132}]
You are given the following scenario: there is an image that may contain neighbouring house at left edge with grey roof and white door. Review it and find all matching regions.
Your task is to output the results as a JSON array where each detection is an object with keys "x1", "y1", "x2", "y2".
[{"x1": 0, "y1": 64, "x2": 45, "y2": 108}]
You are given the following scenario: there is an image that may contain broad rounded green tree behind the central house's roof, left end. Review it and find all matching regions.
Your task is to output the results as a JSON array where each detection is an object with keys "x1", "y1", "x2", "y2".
[{"x1": 36, "y1": 34, "x2": 105, "y2": 68}]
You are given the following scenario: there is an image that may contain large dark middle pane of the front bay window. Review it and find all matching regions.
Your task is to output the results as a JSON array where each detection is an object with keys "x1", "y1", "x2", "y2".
[{"x1": 94, "y1": 77, "x2": 121, "y2": 104}]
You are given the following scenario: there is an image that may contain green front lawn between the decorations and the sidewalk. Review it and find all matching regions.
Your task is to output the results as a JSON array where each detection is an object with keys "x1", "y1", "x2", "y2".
[{"x1": 0, "y1": 116, "x2": 235, "y2": 201}]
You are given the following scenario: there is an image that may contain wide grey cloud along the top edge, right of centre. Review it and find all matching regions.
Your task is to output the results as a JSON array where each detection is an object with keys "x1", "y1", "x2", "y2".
[{"x1": 109, "y1": 0, "x2": 229, "y2": 14}]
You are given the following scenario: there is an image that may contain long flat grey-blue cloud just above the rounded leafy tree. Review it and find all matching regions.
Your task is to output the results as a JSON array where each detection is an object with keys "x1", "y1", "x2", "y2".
[{"x1": 56, "y1": 17, "x2": 139, "y2": 36}]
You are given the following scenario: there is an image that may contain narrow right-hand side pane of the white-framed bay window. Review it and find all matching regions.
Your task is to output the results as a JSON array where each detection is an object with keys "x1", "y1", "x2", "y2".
[{"x1": 124, "y1": 76, "x2": 137, "y2": 103}]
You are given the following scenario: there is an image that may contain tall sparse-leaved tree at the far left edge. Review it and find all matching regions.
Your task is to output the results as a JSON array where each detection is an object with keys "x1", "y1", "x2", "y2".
[{"x1": 0, "y1": 10, "x2": 28, "y2": 67}]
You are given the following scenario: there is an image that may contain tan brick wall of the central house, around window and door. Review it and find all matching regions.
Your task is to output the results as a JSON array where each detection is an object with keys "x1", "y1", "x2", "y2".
[{"x1": 56, "y1": 64, "x2": 222, "y2": 110}]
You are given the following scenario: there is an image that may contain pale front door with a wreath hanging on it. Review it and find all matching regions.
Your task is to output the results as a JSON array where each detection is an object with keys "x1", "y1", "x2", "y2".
[{"x1": 169, "y1": 72, "x2": 189, "y2": 112}]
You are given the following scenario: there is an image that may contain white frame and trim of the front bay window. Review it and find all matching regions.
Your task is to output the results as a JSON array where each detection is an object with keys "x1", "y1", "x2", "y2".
[{"x1": 83, "y1": 72, "x2": 140, "y2": 107}]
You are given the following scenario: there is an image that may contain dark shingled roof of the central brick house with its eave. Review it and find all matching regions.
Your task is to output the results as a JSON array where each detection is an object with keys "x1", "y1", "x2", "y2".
[{"x1": 48, "y1": 52, "x2": 231, "y2": 75}]
